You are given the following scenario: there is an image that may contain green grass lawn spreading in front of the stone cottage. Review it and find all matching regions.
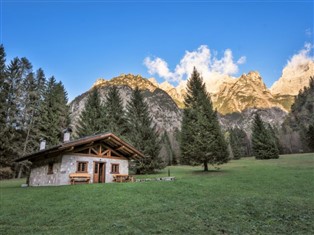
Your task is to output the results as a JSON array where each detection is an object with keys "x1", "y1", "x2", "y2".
[{"x1": 0, "y1": 154, "x2": 314, "y2": 234}]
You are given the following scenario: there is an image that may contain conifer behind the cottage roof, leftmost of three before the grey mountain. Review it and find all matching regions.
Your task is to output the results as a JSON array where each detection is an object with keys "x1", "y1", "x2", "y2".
[{"x1": 76, "y1": 88, "x2": 106, "y2": 138}]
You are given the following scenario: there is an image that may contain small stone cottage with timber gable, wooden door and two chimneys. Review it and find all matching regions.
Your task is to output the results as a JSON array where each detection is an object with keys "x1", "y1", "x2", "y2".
[{"x1": 17, "y1": 133, "x2": 144, "y2": 186}]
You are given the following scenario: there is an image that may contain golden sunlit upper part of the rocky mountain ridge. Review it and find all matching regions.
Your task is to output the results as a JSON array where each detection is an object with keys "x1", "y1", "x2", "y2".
[{"x1": 87, "y1": 61, "x2": 314, "y2": 115}]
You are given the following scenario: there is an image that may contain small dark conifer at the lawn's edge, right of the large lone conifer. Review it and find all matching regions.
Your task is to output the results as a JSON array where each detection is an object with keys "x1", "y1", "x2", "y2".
[{"x1": 252, "y1": 114, "x2": 279, "y2": 159}]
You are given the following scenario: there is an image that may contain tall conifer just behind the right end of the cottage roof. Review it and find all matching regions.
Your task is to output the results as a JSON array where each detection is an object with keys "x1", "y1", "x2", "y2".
[{"x1": 127, "y1": 88, "x2": 163, "y2": 174}]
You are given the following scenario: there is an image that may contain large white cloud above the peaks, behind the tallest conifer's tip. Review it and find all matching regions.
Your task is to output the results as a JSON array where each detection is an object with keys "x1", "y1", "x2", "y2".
[{"x1": 144, "y1": 45, "x2": 246, "y2": 83}]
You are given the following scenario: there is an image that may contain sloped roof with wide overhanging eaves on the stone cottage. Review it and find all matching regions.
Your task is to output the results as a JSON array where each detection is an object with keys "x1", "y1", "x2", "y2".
[{"x1": 16, "y1": 133, "x2": 145, "y2": 162}]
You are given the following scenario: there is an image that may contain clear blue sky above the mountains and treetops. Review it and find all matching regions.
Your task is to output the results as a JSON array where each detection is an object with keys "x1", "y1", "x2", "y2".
[{"x1": 1, "y1": 0, "x2": 314, "y2": 99}]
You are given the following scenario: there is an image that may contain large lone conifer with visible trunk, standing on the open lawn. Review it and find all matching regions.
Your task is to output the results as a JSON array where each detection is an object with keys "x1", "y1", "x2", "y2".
[{"x1": 181, "y1": 68, "x2": 228, "y2": 171}]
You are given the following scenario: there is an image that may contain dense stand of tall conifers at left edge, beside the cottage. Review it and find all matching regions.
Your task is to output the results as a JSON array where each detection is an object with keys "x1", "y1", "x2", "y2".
[{"x1": 0, "y1": 45, "x2": 70, "y2": 175}]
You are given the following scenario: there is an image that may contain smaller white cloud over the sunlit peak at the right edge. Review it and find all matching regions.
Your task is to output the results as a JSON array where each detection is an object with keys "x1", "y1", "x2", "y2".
[{"x1": 284, "y1": 43, "x2": 314, "y2": 70}]
